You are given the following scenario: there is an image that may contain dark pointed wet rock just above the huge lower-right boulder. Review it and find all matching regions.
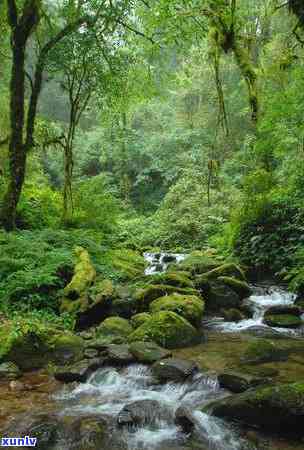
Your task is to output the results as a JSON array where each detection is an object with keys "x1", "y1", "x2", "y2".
[{"x1": 218, "y1": 371, "x2": 269, "y2": 394}]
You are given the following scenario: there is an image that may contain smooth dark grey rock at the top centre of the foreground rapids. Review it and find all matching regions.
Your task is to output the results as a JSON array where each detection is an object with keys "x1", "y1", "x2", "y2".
[{"x1": 152, "y1": 358, "x2": 198, "y2": 381}]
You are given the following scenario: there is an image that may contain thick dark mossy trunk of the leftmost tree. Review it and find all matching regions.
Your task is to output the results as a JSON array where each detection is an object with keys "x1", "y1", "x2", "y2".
[{"x1": 1, "y1": 31, "x2": 26, "y2": 231}]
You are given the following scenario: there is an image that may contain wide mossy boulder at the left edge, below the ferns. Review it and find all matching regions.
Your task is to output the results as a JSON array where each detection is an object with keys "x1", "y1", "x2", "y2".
[{"x1": 0, "y1": 323, "x2": 84, "y2": 370}]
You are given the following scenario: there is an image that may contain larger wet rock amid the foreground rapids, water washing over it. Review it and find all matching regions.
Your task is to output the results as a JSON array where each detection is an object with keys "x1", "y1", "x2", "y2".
[{"x1": 117, "y1": 399, "x2": 170, "y2": 427}]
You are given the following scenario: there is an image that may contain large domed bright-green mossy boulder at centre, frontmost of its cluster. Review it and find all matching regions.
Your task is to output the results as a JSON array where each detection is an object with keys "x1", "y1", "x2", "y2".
[{"x1": 129, "y1": 311, "x2": 199, "y2": 349}]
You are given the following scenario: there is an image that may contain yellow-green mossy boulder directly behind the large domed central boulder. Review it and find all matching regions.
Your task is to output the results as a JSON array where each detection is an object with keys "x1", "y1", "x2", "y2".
[{"x1": 150, "y1": 294, "x2": 205, "y2": 327}]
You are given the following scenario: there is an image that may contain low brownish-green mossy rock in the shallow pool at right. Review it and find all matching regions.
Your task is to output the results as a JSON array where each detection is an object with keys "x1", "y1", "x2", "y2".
[{"x1": 241, "y1": 339, "x2": 288, "y2": 364}]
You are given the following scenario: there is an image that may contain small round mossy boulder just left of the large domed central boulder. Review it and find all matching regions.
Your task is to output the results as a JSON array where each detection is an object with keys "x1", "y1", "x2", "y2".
[{"x1": 96, "y1": 316, "x2": 133, "y2": 344}]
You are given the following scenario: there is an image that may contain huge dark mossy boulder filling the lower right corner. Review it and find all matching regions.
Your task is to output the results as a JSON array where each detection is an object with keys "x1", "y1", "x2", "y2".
[{"x1": 209, "y1": 382, "x2": 304, "y2": 436}]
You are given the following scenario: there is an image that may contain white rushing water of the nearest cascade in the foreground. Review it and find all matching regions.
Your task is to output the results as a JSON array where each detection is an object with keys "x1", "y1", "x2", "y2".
[{"x1": 57, "y1": 364, "x2": 252, "y2": 450}]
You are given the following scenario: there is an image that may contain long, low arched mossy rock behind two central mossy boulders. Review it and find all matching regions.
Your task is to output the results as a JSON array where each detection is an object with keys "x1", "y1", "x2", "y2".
[{"x1": 134, "y1": 284, "x2": 199, "y2": 312}]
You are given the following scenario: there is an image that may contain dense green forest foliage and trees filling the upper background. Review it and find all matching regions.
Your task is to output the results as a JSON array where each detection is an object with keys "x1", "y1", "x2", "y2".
[{"x1": 0, "y1": 0, "x2": 304, "y2": 326}]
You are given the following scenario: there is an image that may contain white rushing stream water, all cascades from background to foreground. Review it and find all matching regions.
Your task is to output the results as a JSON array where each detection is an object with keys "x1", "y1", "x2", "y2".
[{"x1": 51, "y1": 253, "x2": 302, "y2": 450}]
